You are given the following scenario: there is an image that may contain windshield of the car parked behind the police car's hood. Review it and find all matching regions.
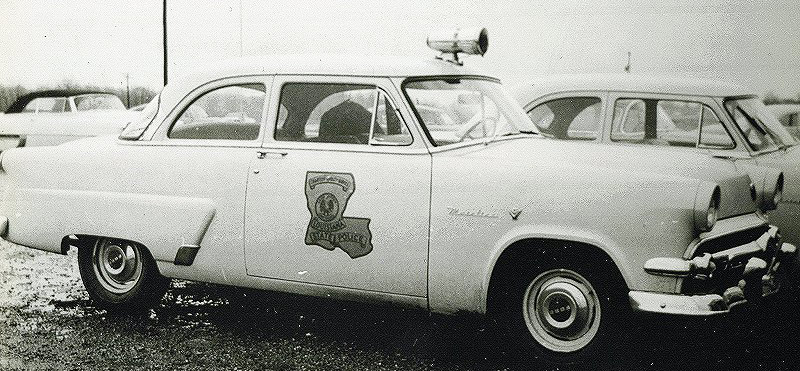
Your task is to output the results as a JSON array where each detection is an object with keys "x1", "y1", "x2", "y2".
[{"x1": 725, "y1": 97, "x2": 796, "y2": 151}]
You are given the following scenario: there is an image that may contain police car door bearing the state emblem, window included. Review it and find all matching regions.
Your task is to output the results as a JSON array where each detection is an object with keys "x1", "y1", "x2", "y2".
[{"x1": 245, "y1": 76, "x2": 431, "y2": 297}]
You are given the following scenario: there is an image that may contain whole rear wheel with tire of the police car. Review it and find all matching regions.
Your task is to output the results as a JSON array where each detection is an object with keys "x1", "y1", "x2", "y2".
[{"x1": 78, "y1": 237, "x2": 169, "y2": 312}]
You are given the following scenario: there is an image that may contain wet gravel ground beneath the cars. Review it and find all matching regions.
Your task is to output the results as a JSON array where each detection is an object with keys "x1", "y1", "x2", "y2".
[{"x1": 0, "y1": 243, "x2": 800, "y2": 370}]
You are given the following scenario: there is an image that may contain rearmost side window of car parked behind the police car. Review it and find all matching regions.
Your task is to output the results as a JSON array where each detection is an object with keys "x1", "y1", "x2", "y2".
[{"x1": 528, "y1": 97, "x2": 602, "y2": 140}]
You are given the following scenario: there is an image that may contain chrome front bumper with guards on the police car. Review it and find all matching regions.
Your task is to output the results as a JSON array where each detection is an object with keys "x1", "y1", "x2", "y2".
[{"x1": 628, "y1": 227, "x2": 797, "y2": 316}]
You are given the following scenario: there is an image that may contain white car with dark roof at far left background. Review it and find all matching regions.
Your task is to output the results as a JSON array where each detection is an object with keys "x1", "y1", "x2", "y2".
[{"x1": 0, "y1": 90, "x2": 138, "y2": 151}]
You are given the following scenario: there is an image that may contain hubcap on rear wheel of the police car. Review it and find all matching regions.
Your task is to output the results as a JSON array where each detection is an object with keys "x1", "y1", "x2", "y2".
[{"x1": 92, "y1": 239, "x2": 142, "y2": 294}]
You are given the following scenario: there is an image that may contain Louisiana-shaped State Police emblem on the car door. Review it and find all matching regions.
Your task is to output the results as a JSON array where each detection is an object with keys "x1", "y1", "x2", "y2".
[{"x1": 306, "y1": 171, "x2": 372, "y2": 259}]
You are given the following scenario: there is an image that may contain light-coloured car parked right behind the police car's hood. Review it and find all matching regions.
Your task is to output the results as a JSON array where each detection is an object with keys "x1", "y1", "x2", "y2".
[{"x1": 514, "y1": 74, "x2": 800, "y2": 244}]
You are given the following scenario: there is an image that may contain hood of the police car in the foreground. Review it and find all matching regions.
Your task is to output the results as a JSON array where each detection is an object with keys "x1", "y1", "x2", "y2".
[{"x1": 456, "y1": 137, "x2": 756, "y2": 218}]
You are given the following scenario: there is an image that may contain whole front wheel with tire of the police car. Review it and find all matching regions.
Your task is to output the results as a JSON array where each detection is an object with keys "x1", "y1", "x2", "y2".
[{"x1": 500, "y1": 265, "x2": 630, "y2": 366}]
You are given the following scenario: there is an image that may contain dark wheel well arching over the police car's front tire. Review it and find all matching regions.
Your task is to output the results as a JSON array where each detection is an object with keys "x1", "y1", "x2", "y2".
[{"x1": 486, "y1": 239, "x2": 628, "y2": 312}]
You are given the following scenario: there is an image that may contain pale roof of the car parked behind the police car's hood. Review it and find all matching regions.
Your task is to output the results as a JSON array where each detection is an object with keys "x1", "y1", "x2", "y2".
[{"x1": 512, "y1": 73, "x2": 755, "y2": 104}]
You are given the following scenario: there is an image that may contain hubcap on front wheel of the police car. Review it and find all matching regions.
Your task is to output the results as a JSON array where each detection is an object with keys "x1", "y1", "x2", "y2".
[{"x1": 522, "y1": 269, "x2": 600, "y2": 352}]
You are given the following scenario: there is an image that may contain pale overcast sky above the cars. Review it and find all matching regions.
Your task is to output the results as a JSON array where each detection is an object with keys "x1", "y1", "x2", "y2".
[{"x1": 0, "y1": 0, "x2": 800, "y2": 96}]
